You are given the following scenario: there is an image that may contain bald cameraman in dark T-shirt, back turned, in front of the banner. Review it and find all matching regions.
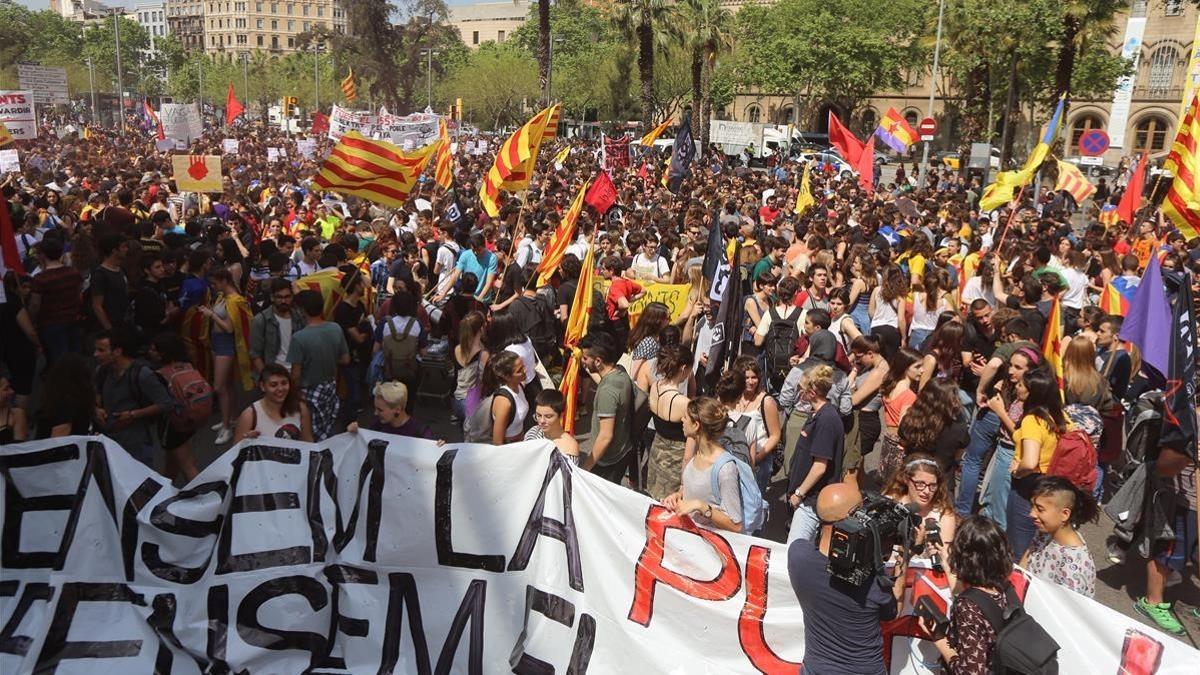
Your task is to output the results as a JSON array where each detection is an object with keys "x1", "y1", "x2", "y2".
[{"x1": 787, "y1": 483, "x2": 905, "y2": 675}]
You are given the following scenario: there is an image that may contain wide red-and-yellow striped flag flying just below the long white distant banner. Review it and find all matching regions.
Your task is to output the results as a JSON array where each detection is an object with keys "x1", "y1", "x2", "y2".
[{"x1": 313, "y1": 131, "x2": 442, "y2": 207}]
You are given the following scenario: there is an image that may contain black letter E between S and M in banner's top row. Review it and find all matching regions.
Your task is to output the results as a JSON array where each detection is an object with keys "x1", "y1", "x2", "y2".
[{"x1": 217, "y1": 446, "x2": 311, "y2": 574}]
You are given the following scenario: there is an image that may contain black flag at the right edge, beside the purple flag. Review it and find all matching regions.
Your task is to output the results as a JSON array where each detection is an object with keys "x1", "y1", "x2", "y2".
[{"x1": 1159, "y1": 269, "x2": 1196, "y2": 456}]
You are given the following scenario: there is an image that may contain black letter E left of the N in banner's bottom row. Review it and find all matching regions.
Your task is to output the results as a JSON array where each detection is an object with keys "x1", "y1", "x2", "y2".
[{"x1": 34, "y1": 581, "x2": 146, "y2": 673}]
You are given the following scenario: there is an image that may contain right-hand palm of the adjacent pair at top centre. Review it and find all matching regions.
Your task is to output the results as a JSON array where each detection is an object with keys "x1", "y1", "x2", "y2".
[{"x1": 683, "y1": 0, "x2": 733, "y2": 148}]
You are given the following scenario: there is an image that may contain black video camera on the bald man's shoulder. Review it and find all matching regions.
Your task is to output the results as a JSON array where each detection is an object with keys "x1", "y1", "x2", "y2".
[{"x1": 828, "y1": 492, "x2": 920, "y2": 586}]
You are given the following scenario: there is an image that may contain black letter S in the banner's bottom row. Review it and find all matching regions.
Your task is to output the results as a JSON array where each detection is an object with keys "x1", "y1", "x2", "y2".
[{"x1": 238, "y1": 574, "x2": 329, "y2": 669}]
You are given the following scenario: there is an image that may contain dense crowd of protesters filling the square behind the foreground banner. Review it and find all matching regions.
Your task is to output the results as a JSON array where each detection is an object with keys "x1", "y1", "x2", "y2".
[{"x1": 0, "y1": 111, "x2": 1200, "y2": 653}]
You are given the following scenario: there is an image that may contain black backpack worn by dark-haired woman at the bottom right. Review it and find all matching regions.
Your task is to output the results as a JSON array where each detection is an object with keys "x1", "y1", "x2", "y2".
[{"x1": 960, "y1": 584, "x2": 1058, "y2": 675}]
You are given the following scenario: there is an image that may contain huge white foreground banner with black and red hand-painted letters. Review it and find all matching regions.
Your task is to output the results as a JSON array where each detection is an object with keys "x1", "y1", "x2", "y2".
[{"x1": 0, "y1": 431, "x2": 1200, "y2": 675}]
